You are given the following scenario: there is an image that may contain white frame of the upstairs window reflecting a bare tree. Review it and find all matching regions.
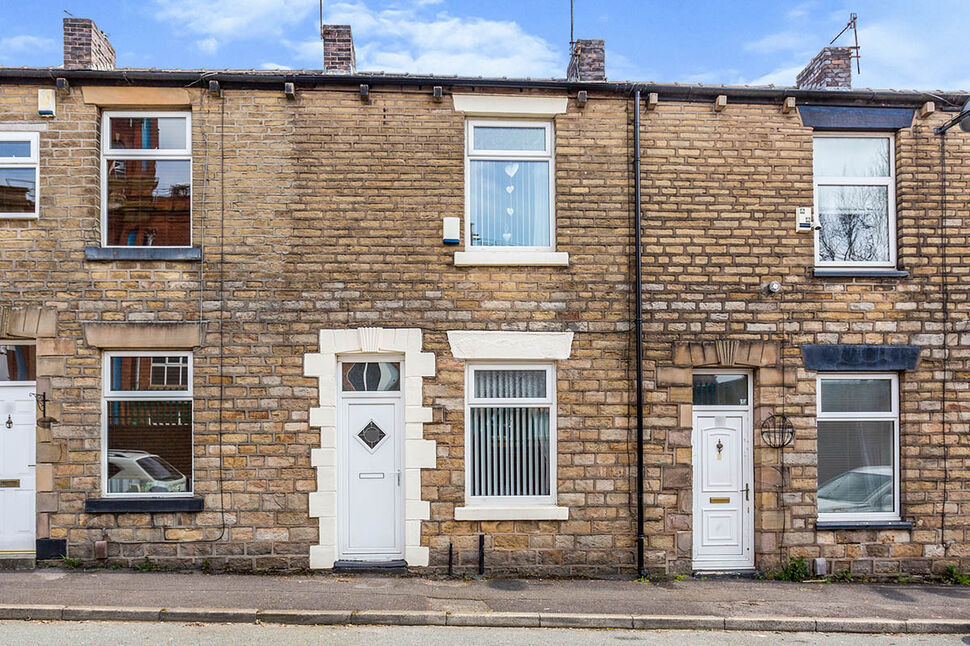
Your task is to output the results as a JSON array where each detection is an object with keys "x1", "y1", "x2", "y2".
[{"x1": 812, "y1": 132, "x2": 897, "y2": 273}]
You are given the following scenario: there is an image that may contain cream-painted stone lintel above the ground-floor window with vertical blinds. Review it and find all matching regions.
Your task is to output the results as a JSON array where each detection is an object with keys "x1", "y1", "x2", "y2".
[{"x1": 448, "y1": 330, "x2": 573, "y2": 360}]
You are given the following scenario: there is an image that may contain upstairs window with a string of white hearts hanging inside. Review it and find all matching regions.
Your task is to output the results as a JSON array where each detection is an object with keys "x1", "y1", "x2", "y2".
[{"x1": 465, "y1": 120, "x2": 554, "y2": 251}]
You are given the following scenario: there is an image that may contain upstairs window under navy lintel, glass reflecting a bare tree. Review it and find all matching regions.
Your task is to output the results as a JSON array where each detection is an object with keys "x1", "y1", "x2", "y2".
[{"x1": 813, "y1": 133, "x2": 896, "y2": 271}]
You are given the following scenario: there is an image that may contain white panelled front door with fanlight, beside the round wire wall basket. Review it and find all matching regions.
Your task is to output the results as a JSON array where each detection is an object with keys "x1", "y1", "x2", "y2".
[{"x1": 692, "y1": 373, "x2": 754, "y2": 570}]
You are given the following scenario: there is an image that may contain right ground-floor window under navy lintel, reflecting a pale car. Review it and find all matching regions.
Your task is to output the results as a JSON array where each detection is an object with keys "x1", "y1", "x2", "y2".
[{"x1": 817, "y1": 373, "x2": 899, "y2": 521}]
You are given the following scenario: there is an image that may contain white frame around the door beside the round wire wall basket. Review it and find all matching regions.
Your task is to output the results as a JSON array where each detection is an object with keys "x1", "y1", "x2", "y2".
[{"x1": 690, "y1": 368, "x2": 755, "y2": 571}]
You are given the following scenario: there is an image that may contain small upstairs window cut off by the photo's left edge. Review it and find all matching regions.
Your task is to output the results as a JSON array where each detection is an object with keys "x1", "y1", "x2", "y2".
[{"x1": 0, "y1": 132, "x2": 40, "y2": 220}]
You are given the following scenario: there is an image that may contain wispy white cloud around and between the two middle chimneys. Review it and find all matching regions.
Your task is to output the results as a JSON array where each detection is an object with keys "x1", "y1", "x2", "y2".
[{"x1": 284, "y1": 2, "x2": 566, "y2": 77}]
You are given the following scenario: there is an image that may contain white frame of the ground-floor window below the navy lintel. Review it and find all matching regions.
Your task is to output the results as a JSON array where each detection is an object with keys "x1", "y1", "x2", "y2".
[{"x1": 815, "y1": 372, "x2": 901, "y2": 522}]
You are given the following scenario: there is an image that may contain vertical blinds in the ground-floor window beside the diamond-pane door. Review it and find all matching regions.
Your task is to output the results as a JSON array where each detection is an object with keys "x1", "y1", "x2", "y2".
[{"x1": 468, "y1": 370, "x2": 551, "y2": 497}]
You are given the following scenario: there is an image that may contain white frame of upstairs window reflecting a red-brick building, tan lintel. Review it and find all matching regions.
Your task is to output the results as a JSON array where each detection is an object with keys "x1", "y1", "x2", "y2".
[{"x1": 101, "y1": 110, "x2": 195, "y2": 249}]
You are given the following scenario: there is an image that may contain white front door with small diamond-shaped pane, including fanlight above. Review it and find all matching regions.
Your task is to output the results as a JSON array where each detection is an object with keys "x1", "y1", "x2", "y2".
[{"x1": 337, "y1": 361, "x2": 404, "y2": 561}]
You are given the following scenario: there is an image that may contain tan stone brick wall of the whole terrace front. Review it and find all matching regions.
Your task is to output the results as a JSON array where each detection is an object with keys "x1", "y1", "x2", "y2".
[{"x1": 0, "y1": 76, "x2": 970, "y2": 575}]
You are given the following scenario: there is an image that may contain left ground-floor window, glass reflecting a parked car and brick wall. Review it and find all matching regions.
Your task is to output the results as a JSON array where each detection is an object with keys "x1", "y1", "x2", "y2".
[{"x1": 101, "y1": 351, "x2": 193, "y2": 497}]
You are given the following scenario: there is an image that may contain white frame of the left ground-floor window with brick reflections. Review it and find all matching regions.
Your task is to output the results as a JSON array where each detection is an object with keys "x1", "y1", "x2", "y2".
[{"x1": 101, "y1": 350, "x2": 195, "y2": 498}]
